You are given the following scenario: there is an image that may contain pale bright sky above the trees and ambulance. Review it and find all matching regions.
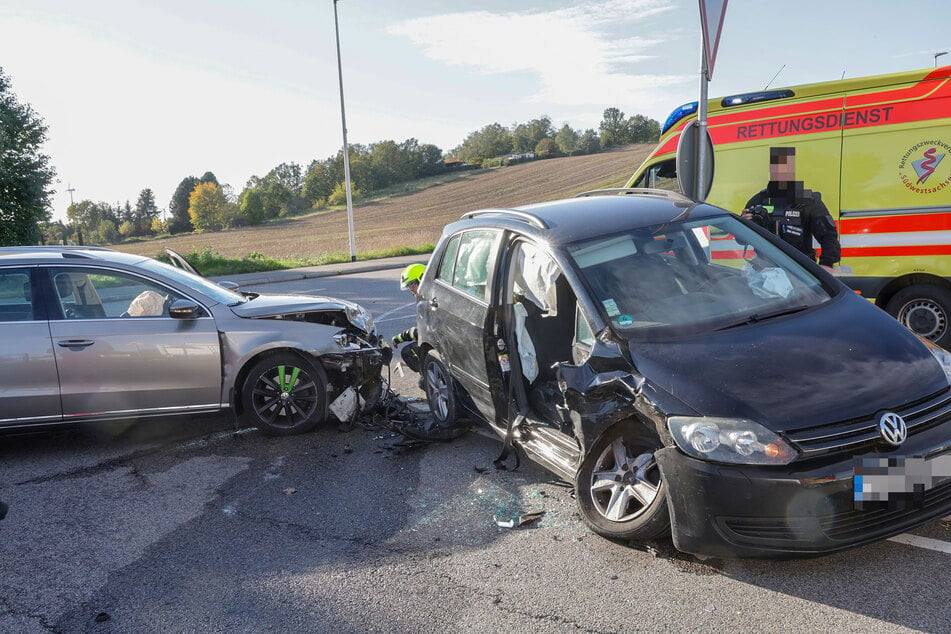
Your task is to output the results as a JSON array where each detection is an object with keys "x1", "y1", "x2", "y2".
[{"x1": 0, "y1": 0, "x2": 951, "y2": 219}]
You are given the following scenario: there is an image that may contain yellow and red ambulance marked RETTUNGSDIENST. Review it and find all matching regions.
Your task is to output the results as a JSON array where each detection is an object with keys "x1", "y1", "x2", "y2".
[{"x1": 627, "y1": 66, "x2": 951, "y2": 348}]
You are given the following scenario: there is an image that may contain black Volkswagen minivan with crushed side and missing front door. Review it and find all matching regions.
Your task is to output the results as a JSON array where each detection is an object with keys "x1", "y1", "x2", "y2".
[{"x1": 417, "y1": 190, "x2": 951, "y2": 557}]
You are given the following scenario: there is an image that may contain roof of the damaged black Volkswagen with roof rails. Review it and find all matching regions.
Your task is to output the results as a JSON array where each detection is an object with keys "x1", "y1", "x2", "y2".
[{"x1": 445, "y1": 189, "x2": 730, "y2": 244}]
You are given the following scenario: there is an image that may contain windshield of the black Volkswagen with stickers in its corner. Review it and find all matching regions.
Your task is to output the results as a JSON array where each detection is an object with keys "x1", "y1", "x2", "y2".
[{"x1": 568, "y1": 216, "x2": 831, "y2": 338}]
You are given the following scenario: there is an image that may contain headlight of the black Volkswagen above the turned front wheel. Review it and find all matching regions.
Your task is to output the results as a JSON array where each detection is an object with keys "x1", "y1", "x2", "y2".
[{"x1": 667, "y1": 416, "x2": 798, "y2": 465}]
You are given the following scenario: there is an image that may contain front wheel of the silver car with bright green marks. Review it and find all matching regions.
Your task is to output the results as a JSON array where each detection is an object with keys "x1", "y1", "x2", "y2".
[{"x1": 241, "y1": 352, "x2": 327, "y2": 436}]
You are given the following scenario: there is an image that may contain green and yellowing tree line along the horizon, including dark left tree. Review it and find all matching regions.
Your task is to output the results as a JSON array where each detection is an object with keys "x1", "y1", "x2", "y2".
[{"x1": 0, "y1": 68, "x2": 660, "y2": 244}]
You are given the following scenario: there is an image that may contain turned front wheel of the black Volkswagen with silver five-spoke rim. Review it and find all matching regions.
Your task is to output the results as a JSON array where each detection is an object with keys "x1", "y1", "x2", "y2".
[{"x1": 575, "y1": 423, "x2": 670, "y2": 541}]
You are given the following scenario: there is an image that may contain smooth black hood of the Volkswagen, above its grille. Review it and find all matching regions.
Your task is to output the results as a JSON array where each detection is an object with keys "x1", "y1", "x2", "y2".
[{"x1": 630, "y1": 294, "x2": 948, "y2": 431}]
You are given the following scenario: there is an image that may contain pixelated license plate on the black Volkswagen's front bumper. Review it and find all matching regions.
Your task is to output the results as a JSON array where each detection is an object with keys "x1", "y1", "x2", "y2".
[{"x1": 852, "y1": 454, "x2": 951, "y2": 509}]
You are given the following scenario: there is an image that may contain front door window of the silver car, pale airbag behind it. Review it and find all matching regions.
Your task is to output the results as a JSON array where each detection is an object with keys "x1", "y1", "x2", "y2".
[{"x1": 50, "y1": 268, "x2": 181, "y2": 319}]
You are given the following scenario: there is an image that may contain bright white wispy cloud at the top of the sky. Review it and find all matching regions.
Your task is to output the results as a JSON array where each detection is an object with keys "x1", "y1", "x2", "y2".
[{"x1": 389, "y1": 0, "x2": 691, "y2": 107}]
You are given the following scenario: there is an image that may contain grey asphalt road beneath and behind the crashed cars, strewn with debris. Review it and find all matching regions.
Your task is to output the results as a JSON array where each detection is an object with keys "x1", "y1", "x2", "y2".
[{"x1": 0, "y1": 262, "x2": 951, "y2": 632}]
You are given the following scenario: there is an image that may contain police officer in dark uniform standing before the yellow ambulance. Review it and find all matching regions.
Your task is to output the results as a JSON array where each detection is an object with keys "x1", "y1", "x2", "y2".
[{"x1": 743, "y1": 147, "x2": 842, "y2": 273}]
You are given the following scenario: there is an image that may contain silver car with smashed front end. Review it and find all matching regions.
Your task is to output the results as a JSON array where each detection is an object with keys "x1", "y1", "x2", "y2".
[{"x1": 0, "y1": 247, "x2": 391, "y2": 435}]
